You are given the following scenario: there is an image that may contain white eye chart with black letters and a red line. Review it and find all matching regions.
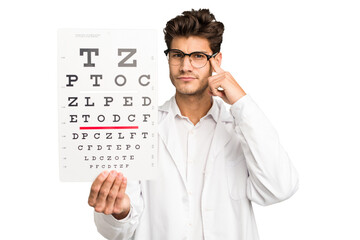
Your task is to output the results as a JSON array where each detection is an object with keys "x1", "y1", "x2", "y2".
[{"x1": 58, "y1": 29, "x2": 157, "y2": 182}]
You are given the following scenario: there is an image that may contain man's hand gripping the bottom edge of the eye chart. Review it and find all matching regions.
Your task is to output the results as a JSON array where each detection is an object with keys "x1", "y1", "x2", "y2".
[{"x1": 88, "y1": 170, "x2": 130, "y2": 220}]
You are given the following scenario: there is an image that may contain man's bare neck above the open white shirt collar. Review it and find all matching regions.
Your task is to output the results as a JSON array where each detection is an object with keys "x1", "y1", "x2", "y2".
[{"x1": 175, "y1": 90, "x2": 212, "y2": 125}]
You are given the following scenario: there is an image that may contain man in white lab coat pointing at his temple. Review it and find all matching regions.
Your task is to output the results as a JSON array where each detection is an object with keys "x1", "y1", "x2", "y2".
[{"x1": 89, "y1": 9, "x2": 298, "y2": 240}]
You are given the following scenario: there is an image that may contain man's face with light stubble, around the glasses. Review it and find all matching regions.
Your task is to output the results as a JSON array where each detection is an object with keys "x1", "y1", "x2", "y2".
[{"x1": 169, "y1": 36, "x2": 213, "y2": 95}]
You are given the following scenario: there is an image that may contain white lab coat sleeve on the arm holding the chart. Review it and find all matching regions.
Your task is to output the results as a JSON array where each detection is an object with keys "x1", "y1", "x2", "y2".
[{"x1": 94, "y1": 181, "x2": 144, "y2": 240}]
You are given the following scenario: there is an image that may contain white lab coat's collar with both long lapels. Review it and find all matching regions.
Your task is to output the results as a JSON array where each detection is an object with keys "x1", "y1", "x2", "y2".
[{"x1": 158, "y1": 97, "x2": 234, "y2": 187}]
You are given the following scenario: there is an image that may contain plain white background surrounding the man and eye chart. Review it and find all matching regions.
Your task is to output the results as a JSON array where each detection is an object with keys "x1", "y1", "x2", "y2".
[{"x1": 0, "y1": 0, "x2": 360, "y2": 240}]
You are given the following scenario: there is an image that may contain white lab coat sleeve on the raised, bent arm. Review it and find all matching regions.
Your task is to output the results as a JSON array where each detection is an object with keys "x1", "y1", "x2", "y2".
[{"x1": 230, "y1": 95, "x2": 298, "y2": 205}]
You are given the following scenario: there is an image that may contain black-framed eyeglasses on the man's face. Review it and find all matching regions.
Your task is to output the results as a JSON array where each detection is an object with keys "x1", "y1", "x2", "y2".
[{"x1": 164, "y1": 49, "x2": 218, "y2": 68}]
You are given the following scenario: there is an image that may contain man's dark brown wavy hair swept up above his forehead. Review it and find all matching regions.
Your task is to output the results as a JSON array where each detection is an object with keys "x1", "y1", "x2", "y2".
[{"x1": 164, "y1": 9, "x2": 224, "y2": 53}]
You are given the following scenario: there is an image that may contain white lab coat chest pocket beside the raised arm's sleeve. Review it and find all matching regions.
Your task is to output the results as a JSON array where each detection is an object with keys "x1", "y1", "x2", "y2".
[{"x1": 226, "y1": 158, "x2": 248, "y2": 200}]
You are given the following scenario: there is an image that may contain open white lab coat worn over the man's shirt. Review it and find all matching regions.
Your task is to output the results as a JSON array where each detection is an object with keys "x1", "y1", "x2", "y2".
[{"x1": 95, "y1": 95, "x2": 298, "y2": 240}]
